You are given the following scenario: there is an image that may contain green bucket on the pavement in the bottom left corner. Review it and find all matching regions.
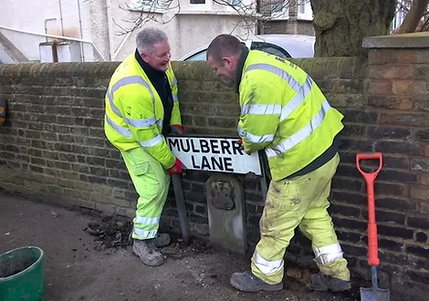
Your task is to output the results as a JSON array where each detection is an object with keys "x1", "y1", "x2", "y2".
[{"x1": 0, "y1": 246, "x2": 45, "y2": 301}]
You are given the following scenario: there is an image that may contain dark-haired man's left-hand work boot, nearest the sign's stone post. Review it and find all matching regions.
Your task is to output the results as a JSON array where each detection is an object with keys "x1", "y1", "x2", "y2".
[{"x1": 230, "y1": 271, "x2": 283, "y2": 292}]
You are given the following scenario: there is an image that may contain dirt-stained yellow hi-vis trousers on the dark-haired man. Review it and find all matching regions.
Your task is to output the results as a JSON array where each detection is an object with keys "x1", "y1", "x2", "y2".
[{"x1": 252, "y1": 154, "x2": 350, "y2": 284}]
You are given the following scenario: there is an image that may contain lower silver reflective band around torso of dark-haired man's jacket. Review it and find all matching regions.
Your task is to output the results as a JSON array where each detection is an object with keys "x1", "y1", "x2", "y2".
[{"x1": 265, "y1": 100, "x2": 331, "y2": 158}]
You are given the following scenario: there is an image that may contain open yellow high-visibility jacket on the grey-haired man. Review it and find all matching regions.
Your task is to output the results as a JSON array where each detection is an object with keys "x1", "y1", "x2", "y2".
[{"x1": 104, "y1": 54, "x2": 182, "y2": 169}]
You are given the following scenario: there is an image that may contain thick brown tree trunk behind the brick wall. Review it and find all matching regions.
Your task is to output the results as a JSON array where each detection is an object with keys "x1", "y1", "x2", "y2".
[{"x1": 311, "y1": 0, "x2": 396, "y2": 57}]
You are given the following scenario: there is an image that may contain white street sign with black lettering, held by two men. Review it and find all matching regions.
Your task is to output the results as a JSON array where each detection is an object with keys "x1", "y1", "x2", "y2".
[{"x1": 167, "y1": 136, "x2": 262, "y2": 176}]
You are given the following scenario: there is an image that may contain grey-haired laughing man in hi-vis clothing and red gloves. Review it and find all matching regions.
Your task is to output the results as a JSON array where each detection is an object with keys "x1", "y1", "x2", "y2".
[{"x1": 104, "y1": 28, "x2": 184, "y2": 266}]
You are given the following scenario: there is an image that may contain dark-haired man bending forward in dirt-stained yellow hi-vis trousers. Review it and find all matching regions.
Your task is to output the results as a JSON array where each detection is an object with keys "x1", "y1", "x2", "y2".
[{"x1": 207, "y1": 35, "x2": 351, "y2": 292}]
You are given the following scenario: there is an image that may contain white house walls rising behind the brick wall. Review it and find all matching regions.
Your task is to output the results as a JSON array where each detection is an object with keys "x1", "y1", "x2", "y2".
[{"x1": 0, "y1": 0, "x2": 254, "y2": 61}]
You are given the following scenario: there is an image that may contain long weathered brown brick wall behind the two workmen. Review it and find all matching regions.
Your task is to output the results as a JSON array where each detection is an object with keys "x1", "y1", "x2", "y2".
[{"x1": 0, "y1": 33, "x2": 429, "y2": 300}]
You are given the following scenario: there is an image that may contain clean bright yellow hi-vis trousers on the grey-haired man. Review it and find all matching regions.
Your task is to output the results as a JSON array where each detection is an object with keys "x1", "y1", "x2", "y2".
[{"x1": 121, "y1": 148, "x2": 170, "y2": 240}]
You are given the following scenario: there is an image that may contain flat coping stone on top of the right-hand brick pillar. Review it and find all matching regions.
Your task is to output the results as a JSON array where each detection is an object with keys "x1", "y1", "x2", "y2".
[{"x1": 362, "y1": 32, "x2": 429, "y2": 49}]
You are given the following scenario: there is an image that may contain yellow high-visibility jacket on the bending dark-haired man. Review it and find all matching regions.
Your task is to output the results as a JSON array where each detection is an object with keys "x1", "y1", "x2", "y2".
[{"x1": 238, "y1": 50, "x2": 344, "y2": 181}]
